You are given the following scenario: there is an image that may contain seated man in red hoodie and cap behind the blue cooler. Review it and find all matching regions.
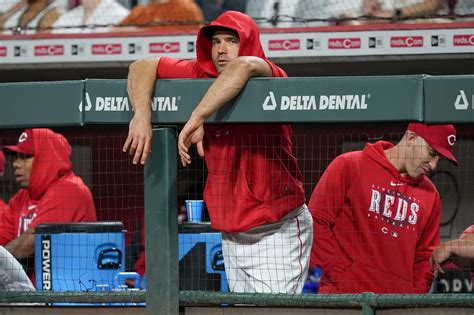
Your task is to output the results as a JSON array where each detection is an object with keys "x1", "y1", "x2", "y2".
[{"x1": 0, "y1": 128, "x2": 97, "y2": 270}]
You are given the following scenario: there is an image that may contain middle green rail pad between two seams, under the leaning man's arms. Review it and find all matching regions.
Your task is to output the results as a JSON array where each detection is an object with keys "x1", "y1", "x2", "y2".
[{"x1": 80, "y1": 76, "x2": 423, "y2": 124}]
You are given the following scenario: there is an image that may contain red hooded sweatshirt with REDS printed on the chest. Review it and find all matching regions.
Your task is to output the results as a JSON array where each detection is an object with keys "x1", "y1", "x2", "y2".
[{"x1": 309, "y1": 141, "x2": 441, "y2": 293}]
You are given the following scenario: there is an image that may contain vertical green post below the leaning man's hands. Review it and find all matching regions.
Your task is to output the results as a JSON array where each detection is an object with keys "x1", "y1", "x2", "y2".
[{"x1": 145, "y1": 128, "x2": 179, "y2": 315}]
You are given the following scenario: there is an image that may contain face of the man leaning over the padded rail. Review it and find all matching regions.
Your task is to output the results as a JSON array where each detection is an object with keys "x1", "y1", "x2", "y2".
[{"x1": 212, "y1": 30, "x2": 240, "y2": 74}]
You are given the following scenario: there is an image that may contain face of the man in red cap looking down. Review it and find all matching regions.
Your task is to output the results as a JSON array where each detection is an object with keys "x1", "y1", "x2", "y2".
[{"x1": 406, "y1": 135, "x2": 440, "y2": 178}]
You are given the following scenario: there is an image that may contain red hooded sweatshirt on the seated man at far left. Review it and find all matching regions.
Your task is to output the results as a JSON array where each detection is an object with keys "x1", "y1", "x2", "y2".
[{"x1": 0, "y1": 128, "x2": 97, "y2": 245}]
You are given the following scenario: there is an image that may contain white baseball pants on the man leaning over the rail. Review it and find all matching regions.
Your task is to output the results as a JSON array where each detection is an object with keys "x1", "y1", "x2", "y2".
[{"x1": 222, "y1": 204, "x2": 313, "y2": 294}]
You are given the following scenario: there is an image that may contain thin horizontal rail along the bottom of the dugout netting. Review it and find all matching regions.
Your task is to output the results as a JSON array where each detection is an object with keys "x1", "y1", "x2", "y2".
[{"x1": 0, "y1": 292, "x2": 474, "y2": 308}]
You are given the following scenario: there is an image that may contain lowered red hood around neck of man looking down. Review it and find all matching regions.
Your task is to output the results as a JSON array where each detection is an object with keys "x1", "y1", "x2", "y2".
[{"x1": 364, "y1": 141, "x2": 425, "y2": 185}]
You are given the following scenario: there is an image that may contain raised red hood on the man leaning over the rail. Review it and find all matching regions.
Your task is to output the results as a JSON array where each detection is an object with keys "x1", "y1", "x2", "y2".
[{"x1": 196, "y1": 11, "x2": 267, "y2": 77}]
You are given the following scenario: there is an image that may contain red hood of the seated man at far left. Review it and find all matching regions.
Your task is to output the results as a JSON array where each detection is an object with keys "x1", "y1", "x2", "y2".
[{"x1": 28, "y1": 128, "x2": 72, "y2": 200}]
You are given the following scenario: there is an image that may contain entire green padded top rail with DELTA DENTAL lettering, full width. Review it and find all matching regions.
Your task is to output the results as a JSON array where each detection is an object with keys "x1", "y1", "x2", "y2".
[{"x1": 0, "y1": 75, "x2": 474, "y2": 128}]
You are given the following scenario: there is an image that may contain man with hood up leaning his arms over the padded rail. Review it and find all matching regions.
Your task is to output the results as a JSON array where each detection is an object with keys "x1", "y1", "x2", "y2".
[{"x1": 123, "y1": 11, "x2": 312, "y2": 293}]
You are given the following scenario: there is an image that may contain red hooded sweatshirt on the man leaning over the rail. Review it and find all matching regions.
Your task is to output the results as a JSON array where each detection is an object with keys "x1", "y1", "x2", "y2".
[{"x1": 157, "y1": 11, "x2": 305, "y2": 232}]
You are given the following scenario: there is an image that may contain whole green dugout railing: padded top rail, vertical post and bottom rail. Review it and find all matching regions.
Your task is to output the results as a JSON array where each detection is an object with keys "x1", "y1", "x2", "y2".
[{"x1": 0, "y1": 76, "x2": 474, "y2": 314}]
